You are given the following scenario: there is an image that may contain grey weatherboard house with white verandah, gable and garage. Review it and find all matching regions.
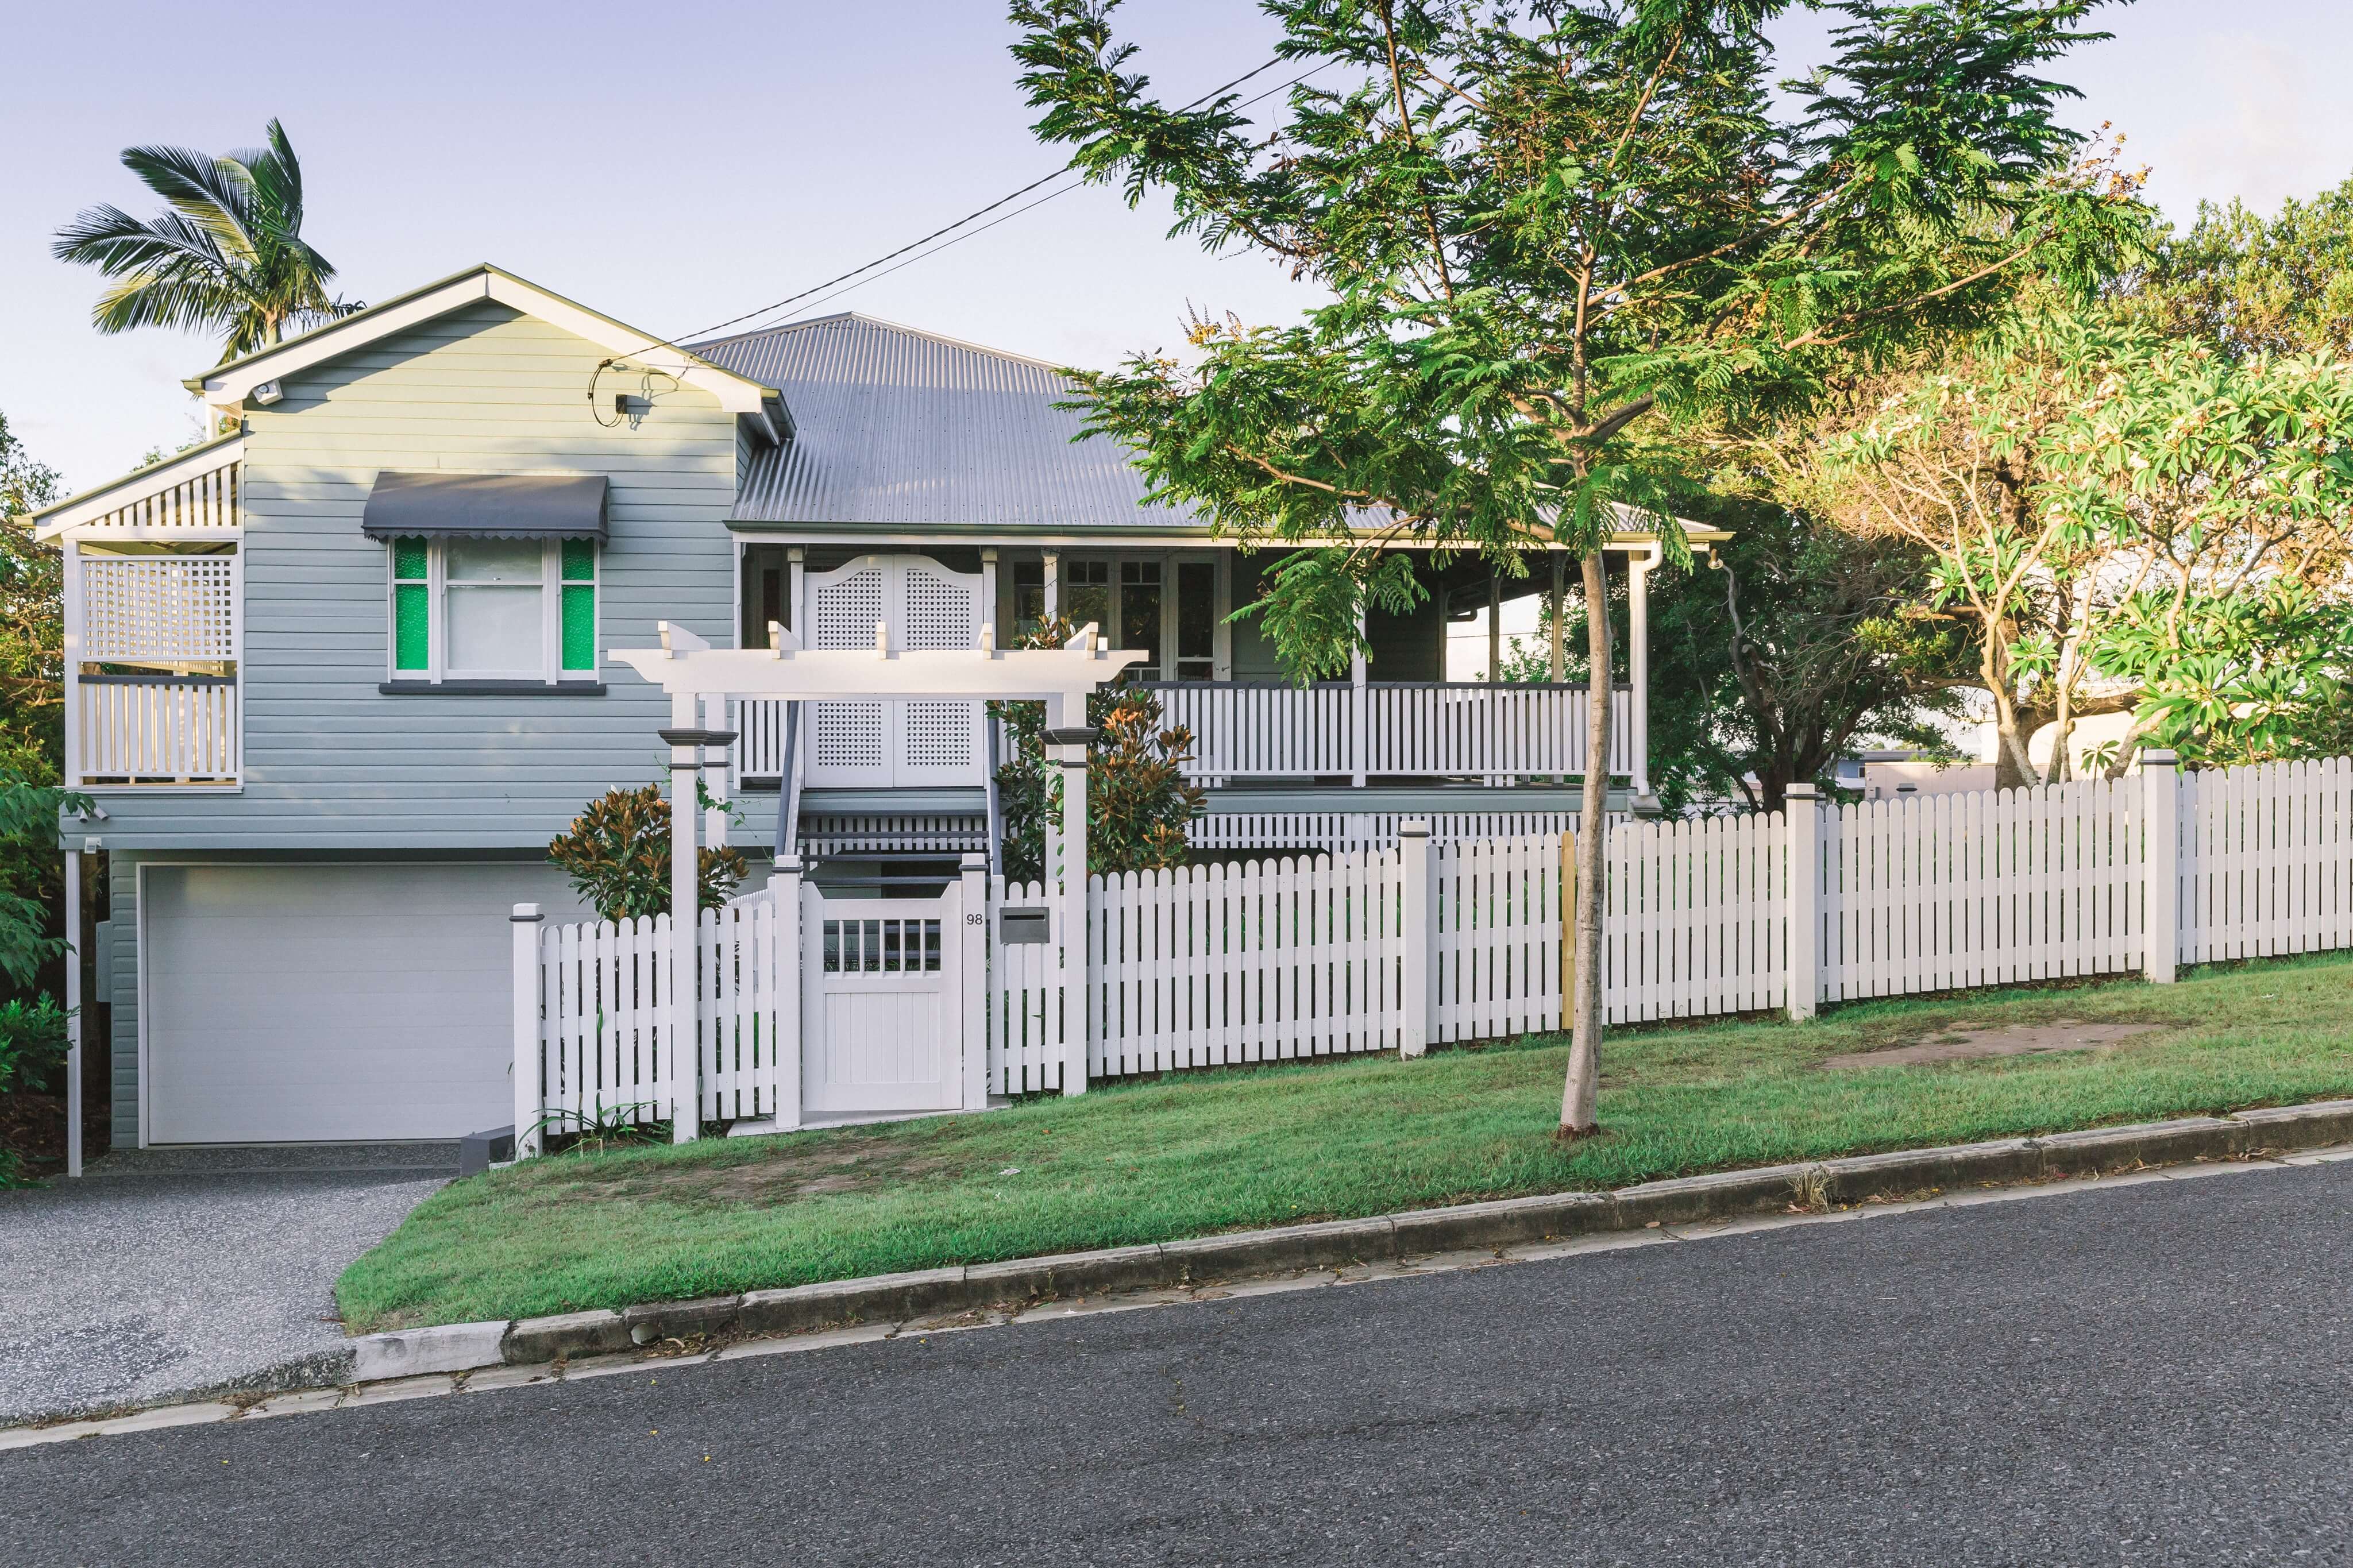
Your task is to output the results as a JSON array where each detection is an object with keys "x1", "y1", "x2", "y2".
[{"x1": 35, "y1": 266, "x2": 1708, "y2": 1145}]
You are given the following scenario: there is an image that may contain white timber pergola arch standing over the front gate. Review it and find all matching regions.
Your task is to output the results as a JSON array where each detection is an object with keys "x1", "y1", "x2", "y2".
[{"x1": 602, "y1": 621, "x2": 1144, "y2": 1142}]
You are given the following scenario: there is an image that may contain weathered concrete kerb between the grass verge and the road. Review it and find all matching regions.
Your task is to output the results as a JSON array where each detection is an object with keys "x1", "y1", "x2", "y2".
[{"x1": 225, "y1": 1100, "x2": 2353, "y2": 1382}]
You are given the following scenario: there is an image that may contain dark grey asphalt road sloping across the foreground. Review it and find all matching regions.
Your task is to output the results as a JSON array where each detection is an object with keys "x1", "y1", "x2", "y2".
[{"x1": 0, "y1": 1164, "x2": 2353, "y2": 1568}]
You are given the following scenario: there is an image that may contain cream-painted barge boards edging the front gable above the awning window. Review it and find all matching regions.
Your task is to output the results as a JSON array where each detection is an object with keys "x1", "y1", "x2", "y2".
[{"x1": 183, "y1": 261, "x2": 779, "y2": 432}]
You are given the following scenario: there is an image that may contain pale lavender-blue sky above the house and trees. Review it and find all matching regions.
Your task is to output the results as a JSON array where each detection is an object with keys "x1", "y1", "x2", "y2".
[{"x1": 0, "y1": 0, "x2": 2353, "y2": 486}]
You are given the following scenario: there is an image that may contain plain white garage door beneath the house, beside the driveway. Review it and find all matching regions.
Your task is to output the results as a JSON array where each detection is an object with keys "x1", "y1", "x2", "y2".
[{"x1": 141, "y1": 863, "x2": 585, "y2": 1142}]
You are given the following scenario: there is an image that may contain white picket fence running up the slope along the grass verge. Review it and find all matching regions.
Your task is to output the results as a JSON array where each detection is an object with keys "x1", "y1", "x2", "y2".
[{"x1": 518, "y1": 759, "x2": 2353, "y2": 1126}]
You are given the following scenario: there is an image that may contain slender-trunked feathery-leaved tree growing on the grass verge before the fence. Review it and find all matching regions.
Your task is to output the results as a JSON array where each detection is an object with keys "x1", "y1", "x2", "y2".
[{"x1": 1012, "y1": 0, "x2": 2127, "y2": 1136}]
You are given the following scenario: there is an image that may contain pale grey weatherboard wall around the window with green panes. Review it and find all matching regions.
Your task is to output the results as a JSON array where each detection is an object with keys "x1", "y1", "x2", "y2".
[{"x1": 91, "y1": 301, "x2": 739, "y2": 849}]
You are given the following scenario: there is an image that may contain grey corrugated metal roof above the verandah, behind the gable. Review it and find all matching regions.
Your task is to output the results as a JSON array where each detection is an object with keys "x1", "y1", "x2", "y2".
[{"x1": 692, "y1": 312, "x2": 1200, "y2": 529}]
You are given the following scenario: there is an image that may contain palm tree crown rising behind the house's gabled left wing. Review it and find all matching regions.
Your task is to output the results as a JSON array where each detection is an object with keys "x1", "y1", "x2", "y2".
[{"x1": 49, "y1": 120, "x2": 360, "y2": 362}]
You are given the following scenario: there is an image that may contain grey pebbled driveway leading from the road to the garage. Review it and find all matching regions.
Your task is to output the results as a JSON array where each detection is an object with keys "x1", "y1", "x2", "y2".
[{"x1": 0, "y1": 1142, "x2": 457, "y2": 1424}]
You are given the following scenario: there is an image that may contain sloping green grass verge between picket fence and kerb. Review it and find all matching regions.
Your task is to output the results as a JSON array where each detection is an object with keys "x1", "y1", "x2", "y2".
[{"x1": 337, "y1": 955, "x2": 2353, "y2": 1333}]
